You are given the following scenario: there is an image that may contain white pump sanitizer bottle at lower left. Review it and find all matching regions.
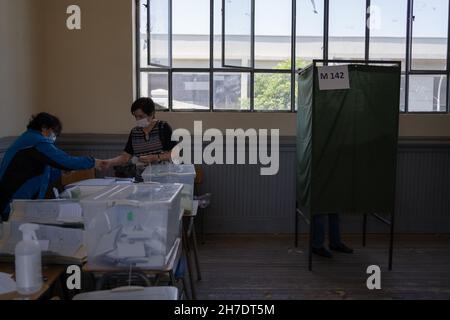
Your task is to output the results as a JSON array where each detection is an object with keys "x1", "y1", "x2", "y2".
[{"x1": 15, "y1": 223, "x2": 42, "y2": 295}]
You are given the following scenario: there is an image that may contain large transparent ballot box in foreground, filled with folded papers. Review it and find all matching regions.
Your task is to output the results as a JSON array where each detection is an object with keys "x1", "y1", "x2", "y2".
[{"x1": 80, "y1": 184, "x2": 183, "y2": 269}]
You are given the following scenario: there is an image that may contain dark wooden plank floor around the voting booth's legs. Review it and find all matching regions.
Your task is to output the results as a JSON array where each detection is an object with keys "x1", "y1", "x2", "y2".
[{"x1": 197, "y1": 235, "x2": 450, "y2": 300}]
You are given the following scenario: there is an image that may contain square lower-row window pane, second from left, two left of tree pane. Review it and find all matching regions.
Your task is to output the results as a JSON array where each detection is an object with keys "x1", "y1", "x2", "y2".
[{"x1": 172, "y1": 72, "x2": 209, "y2": 110}]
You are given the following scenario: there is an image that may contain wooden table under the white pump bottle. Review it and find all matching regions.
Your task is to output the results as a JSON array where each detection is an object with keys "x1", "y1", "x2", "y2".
[{"x1": 0, "y1": 263, "x2": 65, "y2": 300}]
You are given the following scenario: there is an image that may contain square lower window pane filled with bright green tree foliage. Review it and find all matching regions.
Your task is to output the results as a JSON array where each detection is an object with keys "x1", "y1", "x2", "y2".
[{"x1": 255, "y1": 73, "x2": 291, "y2": 110}]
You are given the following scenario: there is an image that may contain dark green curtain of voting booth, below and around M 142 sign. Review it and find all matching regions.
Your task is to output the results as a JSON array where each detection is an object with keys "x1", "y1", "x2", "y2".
[{"x1": 297, "y1": 65, "x2": 401, "y2": 214}]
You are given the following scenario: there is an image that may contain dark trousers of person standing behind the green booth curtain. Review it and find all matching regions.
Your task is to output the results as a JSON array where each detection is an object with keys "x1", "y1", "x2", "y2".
[{"x1": 312, "y1": 213, "x2": 341, "y2": 248}]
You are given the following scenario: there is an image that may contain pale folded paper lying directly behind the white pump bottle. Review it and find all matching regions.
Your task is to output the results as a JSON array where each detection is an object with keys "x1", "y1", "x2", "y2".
[{"x1": 0, "y1": 220, "x2": 86, "y2": 264}]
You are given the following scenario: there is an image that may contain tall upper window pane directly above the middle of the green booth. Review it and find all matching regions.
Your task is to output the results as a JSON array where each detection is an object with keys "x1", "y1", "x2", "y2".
[{"x1": 328, "y1": 0, "x2": 366, "y2": 59}]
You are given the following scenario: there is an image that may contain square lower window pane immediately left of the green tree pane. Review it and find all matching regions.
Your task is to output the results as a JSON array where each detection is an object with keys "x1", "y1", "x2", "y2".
[{"x1": 214, "y1": 72, "x2": 250, "y2": 110}]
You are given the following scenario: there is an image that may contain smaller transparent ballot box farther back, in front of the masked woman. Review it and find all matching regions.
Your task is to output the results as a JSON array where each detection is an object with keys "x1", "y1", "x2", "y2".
[{"x1": 142, "y1": 163, "x2": 195, "y2": 211}]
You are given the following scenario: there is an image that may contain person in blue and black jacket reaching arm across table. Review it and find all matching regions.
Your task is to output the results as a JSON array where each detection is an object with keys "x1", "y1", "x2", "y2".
[{"x1": 0, "y1": 113, "x2": 103, "y2": 221}]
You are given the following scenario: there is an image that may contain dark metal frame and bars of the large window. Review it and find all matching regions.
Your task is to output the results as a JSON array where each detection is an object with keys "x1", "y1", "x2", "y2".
[{"x1": 135, "y1": 0, "x2": 450, "y2": 114}]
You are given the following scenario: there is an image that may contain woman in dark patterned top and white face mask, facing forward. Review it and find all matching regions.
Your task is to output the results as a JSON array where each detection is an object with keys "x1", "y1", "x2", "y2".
[{"x1": 106, "y1": 98, "x2": 176, "y2": 182}]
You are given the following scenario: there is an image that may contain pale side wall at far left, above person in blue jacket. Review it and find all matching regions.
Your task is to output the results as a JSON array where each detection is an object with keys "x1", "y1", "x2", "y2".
[{"x1": 0, "y1": 0, "x2": 39, "y2": 137}]
